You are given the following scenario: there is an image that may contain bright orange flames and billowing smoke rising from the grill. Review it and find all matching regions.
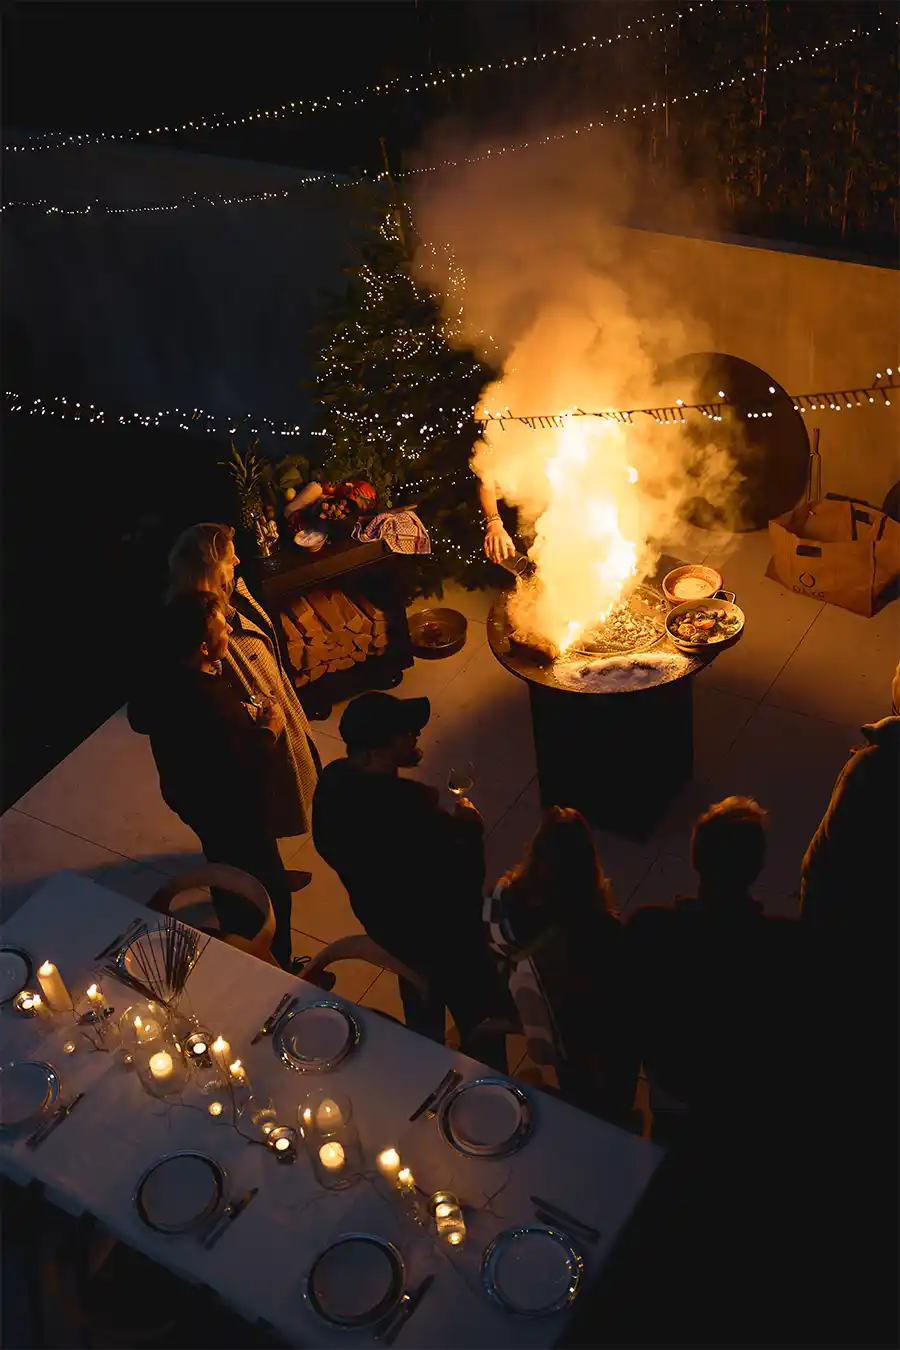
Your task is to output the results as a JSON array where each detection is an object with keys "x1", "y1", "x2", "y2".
[{"x1": 412, "y1": 126, "x2": 741, "y2": 645}]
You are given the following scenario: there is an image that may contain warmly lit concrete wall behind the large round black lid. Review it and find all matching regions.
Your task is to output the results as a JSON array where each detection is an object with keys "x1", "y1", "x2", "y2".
[{"x1": 619, "y1": 230, "x2": 900, "y2": 505}]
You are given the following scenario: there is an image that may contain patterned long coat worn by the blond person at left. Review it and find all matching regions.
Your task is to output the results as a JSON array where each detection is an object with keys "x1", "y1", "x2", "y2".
[{"x1": 225, "y1": 578, "x2": 317, "y2": 838}]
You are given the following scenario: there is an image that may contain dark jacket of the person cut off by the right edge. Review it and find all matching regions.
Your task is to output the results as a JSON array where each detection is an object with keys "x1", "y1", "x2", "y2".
[{"x1": 800, "y1": 717, "x2": 900, "y2": 939}]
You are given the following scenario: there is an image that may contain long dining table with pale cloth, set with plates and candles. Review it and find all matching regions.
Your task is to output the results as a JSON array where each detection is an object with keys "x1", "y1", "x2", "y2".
[{"x1": 0, "y1": 872, "x2": 664, "y2": 1347}]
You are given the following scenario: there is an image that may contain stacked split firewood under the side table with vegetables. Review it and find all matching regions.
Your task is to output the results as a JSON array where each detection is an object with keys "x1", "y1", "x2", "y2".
[{"x1": 281, "y1": 587, "x2": 387, "y2": 686}]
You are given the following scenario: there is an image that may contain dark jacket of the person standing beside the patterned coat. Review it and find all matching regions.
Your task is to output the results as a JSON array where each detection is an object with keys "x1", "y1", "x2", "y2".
[{"x1": 128, "y1": 666, "x2": 285, "y2": 840}]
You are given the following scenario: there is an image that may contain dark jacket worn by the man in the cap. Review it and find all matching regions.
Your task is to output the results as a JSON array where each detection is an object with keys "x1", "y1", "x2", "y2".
[{"x1": 313, "y1": 759, "x2": 495, "y2": 987}]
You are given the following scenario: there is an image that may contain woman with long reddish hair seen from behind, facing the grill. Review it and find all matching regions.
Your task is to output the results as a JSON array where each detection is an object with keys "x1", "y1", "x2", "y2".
[{"x1": 487, "y1": 806, "x2": 640, "y2": 1123}]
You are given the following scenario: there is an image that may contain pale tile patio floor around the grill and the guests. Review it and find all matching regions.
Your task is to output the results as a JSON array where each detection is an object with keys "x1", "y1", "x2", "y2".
[{"x1": 0, "y1": 531, "x2": 900, "y2": 1062}]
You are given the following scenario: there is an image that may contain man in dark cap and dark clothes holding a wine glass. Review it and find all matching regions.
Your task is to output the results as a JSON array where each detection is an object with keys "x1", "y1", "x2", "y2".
[{"x1": 313, "y1": 693, "x2": 510, "y2": 1072}]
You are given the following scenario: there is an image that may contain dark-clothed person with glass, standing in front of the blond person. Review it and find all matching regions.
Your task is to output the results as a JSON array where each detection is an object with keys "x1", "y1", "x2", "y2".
[{"x1": 128, "y1": 591, "x2": 302, "y2": 969}]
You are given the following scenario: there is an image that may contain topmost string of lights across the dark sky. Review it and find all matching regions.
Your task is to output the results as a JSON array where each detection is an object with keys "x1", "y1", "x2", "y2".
[{"x1": 3, "y1": 0, "x2": 712, "y2": 153}]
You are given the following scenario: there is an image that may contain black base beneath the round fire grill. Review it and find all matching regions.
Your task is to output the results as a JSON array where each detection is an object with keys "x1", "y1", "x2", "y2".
[{"x1": 529, "y1": 678, "x2": 694, "y2": 841}]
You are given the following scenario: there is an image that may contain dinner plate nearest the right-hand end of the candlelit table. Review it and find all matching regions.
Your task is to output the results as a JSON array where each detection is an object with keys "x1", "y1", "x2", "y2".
[{"x1": 482, "y1": 1227, "x2": 584, "y2": 1318}]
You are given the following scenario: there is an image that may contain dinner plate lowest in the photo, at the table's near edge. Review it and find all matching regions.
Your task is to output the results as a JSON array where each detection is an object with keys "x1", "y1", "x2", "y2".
[{"x1": 306, "y1": 1233, "x2": 405, "y2": 1328}]
